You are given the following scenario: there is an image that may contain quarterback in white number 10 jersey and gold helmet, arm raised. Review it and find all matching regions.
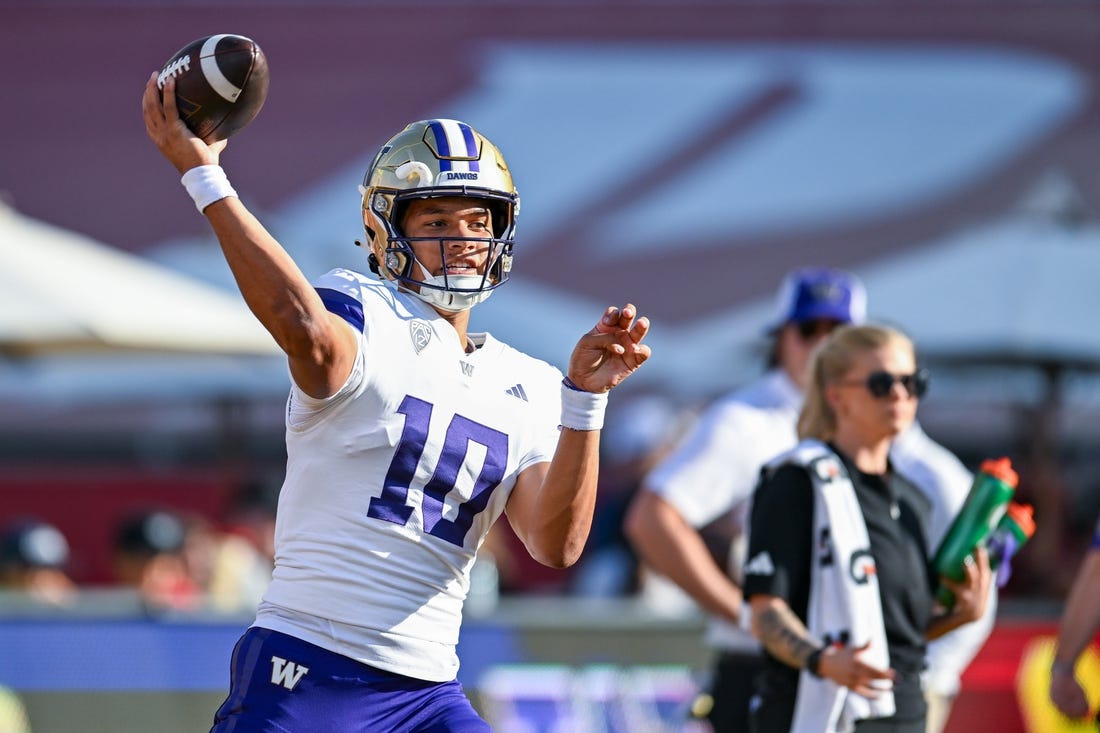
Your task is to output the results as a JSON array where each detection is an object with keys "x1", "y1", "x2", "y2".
[{"x1": 142, "y1": 75, "x2": 650, "y2": 733}]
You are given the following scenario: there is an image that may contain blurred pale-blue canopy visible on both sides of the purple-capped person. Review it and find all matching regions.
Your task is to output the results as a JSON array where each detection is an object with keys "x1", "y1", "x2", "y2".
[{"x1": 677, "y1": 176, "x2": 1100, "y2": 403}]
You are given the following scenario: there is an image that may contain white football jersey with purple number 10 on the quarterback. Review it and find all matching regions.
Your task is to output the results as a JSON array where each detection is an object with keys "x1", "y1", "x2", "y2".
[{"x1": 256, "y1": 270, "x2": 562, "y2": 681}]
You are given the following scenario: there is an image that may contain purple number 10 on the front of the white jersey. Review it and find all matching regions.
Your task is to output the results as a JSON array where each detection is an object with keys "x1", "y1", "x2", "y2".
[{"x1": 366, "y1": 395, "x2": 508, "y2": 547}]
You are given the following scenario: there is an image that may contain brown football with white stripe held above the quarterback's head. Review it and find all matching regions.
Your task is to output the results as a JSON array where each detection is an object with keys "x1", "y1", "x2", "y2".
[{"x1": 156, "y1": 33, "x2": 268, "y2": 143}]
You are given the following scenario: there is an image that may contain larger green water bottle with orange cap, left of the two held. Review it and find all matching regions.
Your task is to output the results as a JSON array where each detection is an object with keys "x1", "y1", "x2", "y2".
[{"x1": 932, "y1": 458, "x2": 1020, "y2": 610}]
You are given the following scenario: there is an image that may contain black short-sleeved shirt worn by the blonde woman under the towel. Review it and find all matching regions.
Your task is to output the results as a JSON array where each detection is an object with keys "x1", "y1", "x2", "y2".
[{"x1": 744, "y1": 446, "x2": 934, "y2": 730}]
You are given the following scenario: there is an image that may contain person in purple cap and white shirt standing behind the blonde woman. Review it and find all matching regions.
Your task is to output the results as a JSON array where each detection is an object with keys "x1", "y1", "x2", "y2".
[{"x1": 625, "y1": 267, "x2": 996, "y2": 733}]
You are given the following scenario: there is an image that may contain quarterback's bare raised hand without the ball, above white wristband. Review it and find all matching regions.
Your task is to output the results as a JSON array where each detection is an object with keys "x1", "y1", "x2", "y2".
[{"x1": 569, "y1": 303, "x2": 650, "y2": 392}]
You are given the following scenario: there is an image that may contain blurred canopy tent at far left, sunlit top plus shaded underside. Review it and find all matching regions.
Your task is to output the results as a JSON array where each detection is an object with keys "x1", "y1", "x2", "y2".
[{"x1": 0, "y1": 205, "x2": 289, "y2": 442}]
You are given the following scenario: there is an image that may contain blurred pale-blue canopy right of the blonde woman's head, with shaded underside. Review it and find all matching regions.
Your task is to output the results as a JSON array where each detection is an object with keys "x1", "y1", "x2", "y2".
[{"x1": 860, "y1": 200, "x2": 1100, "y2": 449}]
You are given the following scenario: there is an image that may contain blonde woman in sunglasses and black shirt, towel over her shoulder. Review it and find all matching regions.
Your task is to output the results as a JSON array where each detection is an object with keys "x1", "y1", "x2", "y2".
[{"x1": 745, "y1": 326, "x2": 992, "y2": 733}]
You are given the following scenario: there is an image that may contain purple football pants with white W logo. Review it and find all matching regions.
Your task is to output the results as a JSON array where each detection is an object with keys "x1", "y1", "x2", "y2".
[{"x1": 210, "y1": 626, "x2": 492, "y2": 733}]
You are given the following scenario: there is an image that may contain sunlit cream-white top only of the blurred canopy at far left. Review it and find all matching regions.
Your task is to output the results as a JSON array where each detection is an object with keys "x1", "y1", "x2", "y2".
[{"x1": 0, "y1": 206, "x2": 277, "y2": 355}]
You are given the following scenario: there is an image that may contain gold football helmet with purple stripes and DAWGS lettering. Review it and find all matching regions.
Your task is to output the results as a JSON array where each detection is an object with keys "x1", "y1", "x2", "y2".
[{"x1": 360, "y1": 120, "x2": 519, "y2": 311}]
